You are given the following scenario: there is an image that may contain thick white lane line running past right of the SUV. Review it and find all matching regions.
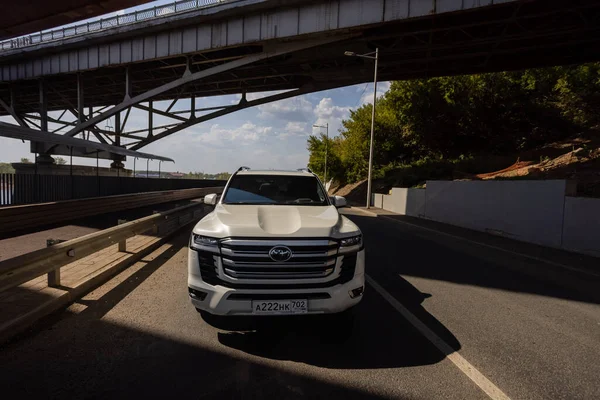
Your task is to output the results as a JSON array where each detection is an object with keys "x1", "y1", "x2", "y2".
[{"x1": 366, "y1": 275, "x2": 510, "y2": 400}]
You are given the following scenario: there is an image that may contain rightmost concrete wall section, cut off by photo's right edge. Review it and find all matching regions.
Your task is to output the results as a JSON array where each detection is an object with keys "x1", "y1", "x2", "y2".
[{"x1": 562, "y1": 196, "x2": 600, "y2": 256}]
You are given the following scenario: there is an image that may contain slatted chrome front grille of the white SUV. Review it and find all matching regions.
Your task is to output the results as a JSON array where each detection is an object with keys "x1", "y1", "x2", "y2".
[{"x1": 220, "y1": 239, "x2": 338, "y2": 280}]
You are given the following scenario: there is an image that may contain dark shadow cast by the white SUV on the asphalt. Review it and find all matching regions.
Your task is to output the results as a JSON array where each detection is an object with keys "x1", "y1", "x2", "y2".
[{"x1": 218, "y1": 281, "x2": 461, "y2": 369}]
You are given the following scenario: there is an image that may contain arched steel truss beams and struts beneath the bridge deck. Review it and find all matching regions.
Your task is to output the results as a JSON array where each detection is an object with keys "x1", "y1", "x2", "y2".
[{"x1": 0, "y1": 35, "x2": 352, "y2": 157}]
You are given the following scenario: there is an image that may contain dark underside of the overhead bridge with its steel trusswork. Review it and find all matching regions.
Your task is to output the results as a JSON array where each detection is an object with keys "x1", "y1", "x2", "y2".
[{"x1": 0, "y1": 0, "x2": 600, "y2": 159}]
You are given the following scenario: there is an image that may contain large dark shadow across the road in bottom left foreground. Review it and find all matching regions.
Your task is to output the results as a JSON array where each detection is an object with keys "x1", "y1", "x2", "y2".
[{"x1": 0, "y1": 314, "x2": 398, "y2": 400}]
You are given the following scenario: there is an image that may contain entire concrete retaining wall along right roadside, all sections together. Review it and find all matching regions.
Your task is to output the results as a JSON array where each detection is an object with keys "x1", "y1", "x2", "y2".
[{"x1": 373, "y1": 180, "x2": 600, "y2": 256}]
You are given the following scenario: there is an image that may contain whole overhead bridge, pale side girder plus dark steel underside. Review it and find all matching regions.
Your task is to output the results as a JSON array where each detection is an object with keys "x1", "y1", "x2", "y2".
[{"x1": 0, "y1": 0, "x2": 600, "y2": 161}]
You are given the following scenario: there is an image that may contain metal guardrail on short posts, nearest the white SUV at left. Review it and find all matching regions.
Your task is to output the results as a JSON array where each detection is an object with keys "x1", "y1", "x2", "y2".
[{"x1": 0, "y1": 198, "x2": 222, "y2": 292}]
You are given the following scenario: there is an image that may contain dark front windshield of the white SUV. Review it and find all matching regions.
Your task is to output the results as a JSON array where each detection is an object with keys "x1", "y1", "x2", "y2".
[{"x1": 223, "y1": 175, "x2": 329, "y2": 206}]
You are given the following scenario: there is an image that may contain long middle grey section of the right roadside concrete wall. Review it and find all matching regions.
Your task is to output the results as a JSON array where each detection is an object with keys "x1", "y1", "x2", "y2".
[{"x1": 426, "y1": 180, "x2": 566, "y2": 247}]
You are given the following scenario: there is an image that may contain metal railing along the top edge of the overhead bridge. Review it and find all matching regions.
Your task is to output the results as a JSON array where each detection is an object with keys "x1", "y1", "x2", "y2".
[{"x1": 0, "y1": 0, "x2": 231, "y2": 50}]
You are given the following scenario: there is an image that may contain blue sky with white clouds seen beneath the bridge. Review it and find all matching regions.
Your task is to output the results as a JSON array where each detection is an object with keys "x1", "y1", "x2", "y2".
[{"x1": 0, "y1": 0, "x2": 389, "y2": 173}]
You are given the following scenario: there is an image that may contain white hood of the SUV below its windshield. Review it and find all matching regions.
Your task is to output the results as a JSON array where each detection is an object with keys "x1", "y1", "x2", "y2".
[{"x1": 194, "y1": 204, "x2": 359, "y2": 238}]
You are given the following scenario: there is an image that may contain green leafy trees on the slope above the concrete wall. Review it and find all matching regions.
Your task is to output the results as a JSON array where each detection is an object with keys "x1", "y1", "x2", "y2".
[{"x1": 307, "y1": 63, "x2": 600, "y2": 182}]
